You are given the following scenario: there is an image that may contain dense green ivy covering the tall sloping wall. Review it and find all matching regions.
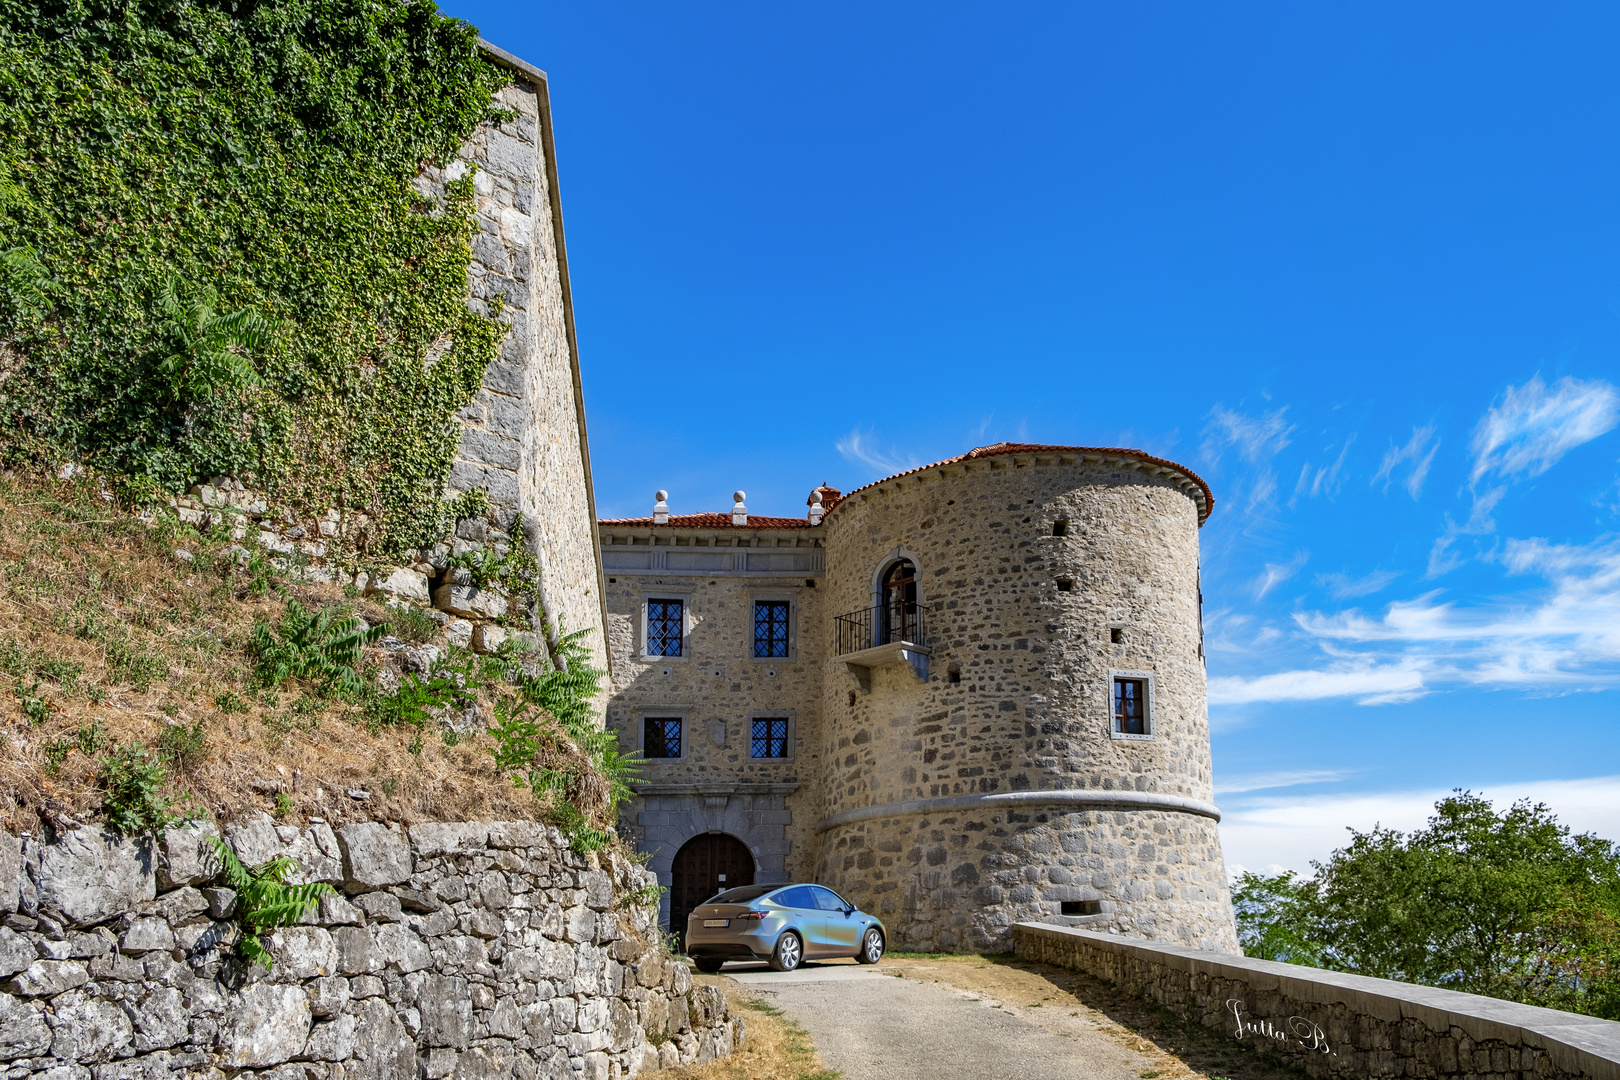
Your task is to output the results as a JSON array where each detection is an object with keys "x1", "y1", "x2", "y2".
[{"x1": 0, "y1": 0, "x2": 505, "y2": 559}]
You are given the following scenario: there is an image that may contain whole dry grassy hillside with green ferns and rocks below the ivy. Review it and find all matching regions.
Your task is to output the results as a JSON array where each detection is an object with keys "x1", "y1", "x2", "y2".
[{"x1": 0, "y1": 470, "x2": 619, "y2": 847}]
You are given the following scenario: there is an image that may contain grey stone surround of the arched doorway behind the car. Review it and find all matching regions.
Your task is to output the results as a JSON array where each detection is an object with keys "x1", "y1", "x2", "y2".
[{"x1": 637, "y1": 784, "x2": 799, "y2": 929}]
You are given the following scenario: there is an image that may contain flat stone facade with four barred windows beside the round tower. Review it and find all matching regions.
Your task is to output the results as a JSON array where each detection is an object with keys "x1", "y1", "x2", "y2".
[{"x1": 604, "y1": 523, "x2": 826, "y2": 921}]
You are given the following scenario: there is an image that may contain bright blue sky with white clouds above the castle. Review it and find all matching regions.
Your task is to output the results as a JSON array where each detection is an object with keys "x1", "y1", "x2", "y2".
[{"x1": 447, "y1": 0, "x2": 1620, "y2": 868}]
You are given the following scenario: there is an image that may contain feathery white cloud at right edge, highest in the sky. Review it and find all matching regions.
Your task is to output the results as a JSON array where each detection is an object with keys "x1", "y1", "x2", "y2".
[{"x1": 1469, "y1": 376, "x2": 1620, "y2": 487}]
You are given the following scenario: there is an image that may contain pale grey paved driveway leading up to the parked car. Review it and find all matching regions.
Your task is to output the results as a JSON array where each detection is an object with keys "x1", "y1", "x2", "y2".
[{"x1": 724, "y1": 963, "x2": 1168, "y2": 1080}]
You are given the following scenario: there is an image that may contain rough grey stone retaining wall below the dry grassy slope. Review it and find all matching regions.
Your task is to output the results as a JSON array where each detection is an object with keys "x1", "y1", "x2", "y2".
[{"x1": 0, "y1": 816, "x2": 744, "y2": 1080}]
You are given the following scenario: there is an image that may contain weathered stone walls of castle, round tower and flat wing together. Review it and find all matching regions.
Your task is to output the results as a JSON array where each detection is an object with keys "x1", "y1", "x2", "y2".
[{"x1": 599, "y1": 444, "x2": 1236, "y2": 950}]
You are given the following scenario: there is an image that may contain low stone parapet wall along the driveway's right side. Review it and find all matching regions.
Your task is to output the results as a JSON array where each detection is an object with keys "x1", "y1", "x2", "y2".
[{"x1": 1013, "y1": 923, "x2": 1620, "y2": 1080}]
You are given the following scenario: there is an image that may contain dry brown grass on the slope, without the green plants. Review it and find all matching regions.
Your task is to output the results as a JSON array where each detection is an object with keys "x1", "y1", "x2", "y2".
[{"x1": 0, "y1": 473, "x2": 536, "y2": 832}]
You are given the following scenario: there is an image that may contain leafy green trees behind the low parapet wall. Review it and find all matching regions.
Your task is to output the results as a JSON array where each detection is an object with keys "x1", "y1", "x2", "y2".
[{"x1": 1234, "y1": 792, "x2": 1620, "y2": 1018}]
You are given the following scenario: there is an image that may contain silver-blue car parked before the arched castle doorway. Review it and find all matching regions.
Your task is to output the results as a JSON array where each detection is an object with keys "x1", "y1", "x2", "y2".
[{"x1": 687, "y1": 884, "x2": 886, "y2": 973}]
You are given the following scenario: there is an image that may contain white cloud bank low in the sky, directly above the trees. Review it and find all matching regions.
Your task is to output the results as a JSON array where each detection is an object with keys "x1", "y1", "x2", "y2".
[{"x1": 1217, "y1": 776, "x2": 1620, "y2": 874}]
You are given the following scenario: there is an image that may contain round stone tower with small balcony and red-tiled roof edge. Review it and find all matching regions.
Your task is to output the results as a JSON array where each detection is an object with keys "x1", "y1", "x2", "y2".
[{"x1": 815, "y1": 444, "x2": 1238, "y2": 952}]
